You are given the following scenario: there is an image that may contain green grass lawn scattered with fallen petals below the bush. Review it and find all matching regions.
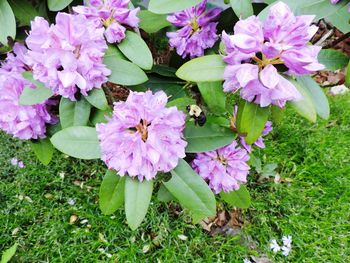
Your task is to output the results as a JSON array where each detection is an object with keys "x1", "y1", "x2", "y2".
[{"x1": 0, "y1": 96, "x2": 350, "y2": 262}]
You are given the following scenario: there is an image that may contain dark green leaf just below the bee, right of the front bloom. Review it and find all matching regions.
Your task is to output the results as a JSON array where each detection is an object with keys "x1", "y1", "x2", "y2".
[{"x1": 184, "y1": 121, "x2": 236, "y2": 153}]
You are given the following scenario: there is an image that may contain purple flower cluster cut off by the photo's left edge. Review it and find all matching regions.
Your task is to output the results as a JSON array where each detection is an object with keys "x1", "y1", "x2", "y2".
[{"x1": 0, "y1": 43, "x2": 56, "y2": 140}]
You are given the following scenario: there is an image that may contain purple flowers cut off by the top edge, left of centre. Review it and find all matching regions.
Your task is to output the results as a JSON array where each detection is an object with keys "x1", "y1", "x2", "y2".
[{"x1": 73, "y1": 0, "x2": 140, "y2": 43}]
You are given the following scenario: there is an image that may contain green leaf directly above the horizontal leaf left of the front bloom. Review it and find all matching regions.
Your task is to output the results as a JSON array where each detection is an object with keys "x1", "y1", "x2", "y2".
[{"x1": 59, "y1": 97, "x2": 91, "y2": 129}]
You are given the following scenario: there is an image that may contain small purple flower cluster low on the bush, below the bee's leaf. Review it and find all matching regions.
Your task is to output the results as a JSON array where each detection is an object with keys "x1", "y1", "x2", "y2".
[{"x1": 192, "y1": 141, "x2": 250, "y2": 194}]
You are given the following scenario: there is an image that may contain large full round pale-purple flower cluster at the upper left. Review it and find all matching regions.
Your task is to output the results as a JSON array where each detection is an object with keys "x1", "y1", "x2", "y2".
[{"x1": 26, "y1": 13, "x2": 110, "y2": 100}]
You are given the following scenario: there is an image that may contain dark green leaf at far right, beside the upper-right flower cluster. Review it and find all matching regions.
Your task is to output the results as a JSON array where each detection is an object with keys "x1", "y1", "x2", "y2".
[{"x1": 318, "y1": 49, "x2": 349, "y2": 71}]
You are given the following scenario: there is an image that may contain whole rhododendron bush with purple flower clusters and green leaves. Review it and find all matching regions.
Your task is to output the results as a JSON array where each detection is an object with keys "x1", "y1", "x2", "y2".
[{"x1": 0, "y1": 0, "x2": 350, "y2": 229}]
